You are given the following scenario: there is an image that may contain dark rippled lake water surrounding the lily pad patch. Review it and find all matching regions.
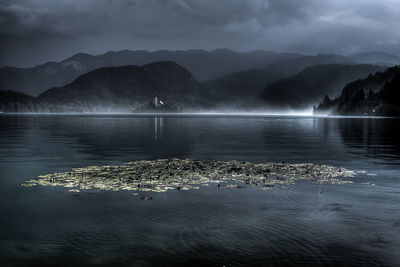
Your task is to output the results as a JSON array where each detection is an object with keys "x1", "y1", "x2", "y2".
[{"x1": 0, "y1": 114, "x2": 400, "y2": 266}]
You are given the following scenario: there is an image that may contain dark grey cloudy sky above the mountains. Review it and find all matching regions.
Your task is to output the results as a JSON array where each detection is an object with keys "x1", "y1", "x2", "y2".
[{"x1": 0, "y1": 0, "x2": 400, "y2": 66}]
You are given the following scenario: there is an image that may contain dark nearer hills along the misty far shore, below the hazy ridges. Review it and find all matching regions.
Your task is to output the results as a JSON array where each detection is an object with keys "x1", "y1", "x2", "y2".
[{"x1": 0, "y1": 62, "x2": 385, "y2": 112}]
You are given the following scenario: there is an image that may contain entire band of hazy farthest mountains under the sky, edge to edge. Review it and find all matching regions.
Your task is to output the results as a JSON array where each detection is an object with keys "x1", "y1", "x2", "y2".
[{"x1": 0, "y1": 49, "x2": 400, "y2": 96}]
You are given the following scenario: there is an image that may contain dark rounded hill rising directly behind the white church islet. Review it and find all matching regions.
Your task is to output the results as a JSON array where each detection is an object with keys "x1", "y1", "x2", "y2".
[{"x1": 37, "y1": 62, "x2": 207, "y2": 112}]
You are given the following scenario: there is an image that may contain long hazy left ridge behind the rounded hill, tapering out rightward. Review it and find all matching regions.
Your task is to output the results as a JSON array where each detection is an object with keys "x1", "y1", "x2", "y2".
[{"x1": 0, "y1": 49, "x2": 300, "y2": 96}]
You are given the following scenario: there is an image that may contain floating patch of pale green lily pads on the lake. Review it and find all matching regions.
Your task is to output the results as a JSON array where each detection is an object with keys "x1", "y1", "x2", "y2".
[{"x1": 22, "y1": 159, "x2": 355, "y2": 192}]
